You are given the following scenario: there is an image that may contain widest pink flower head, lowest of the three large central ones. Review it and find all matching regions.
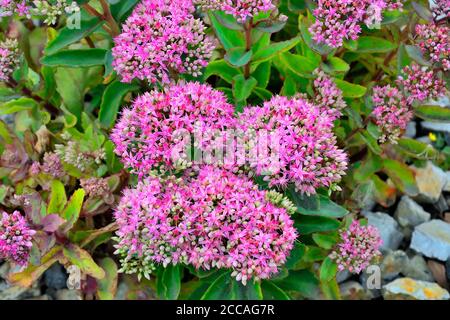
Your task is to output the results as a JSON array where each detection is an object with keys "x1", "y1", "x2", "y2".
[{"x1": 115, "y1": 166, "x2": 297, "y2": 284}]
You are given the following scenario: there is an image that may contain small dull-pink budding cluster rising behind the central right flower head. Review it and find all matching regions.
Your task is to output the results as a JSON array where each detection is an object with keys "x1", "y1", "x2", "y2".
[{"x1": 313, "y1": 69, "x2": 347, "y2": 119}]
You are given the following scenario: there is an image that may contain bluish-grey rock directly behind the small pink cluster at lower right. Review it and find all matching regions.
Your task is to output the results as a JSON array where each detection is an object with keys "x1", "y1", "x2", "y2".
[{"x1": 363, "y1": 212, "x2": 403, "y2": 251}]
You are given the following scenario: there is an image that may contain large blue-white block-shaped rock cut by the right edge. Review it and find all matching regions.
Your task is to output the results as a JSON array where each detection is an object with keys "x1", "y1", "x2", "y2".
[{"x1": 411, "y1": 220, "x2": 450, "y2": 261}]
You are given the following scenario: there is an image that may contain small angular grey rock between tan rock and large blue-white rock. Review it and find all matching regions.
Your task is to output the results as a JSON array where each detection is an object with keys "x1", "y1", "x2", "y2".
[{"x1": 394, "y1": 196, "x2": 431, "y2": 227}]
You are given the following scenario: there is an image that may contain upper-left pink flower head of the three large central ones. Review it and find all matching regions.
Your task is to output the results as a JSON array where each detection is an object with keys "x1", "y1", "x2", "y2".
[{"x1": 111, "y1": 82, "x2": 235, "y2": 177}]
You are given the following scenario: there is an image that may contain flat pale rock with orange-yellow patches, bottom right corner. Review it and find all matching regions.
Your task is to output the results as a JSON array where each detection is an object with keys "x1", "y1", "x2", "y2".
[{"x1": 383, "y1": 278, "x2": 450, "y2": 300}]
